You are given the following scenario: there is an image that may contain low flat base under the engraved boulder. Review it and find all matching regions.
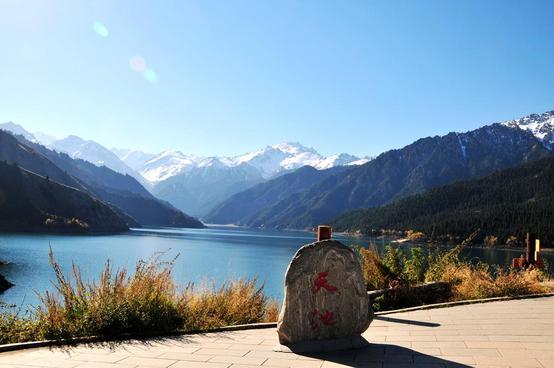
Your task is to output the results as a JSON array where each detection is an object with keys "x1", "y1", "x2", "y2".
[{"x1": 273, "y1": 336, "x2": 369, "y2": 353}]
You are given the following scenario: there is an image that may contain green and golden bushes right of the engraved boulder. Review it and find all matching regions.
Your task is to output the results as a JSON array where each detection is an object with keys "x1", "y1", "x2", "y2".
[{"x1": 356, "y1": 244, "x2": 554, "y2": 311}]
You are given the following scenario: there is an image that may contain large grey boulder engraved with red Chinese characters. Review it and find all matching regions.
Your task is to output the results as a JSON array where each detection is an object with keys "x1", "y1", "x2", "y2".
[{"x1": 276, "y1": 240, "x2": 373, "y2": 351}]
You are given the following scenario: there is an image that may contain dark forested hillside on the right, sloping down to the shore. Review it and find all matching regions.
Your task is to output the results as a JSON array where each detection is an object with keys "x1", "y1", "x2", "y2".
[{"x1": 333, "y1": 156, "x2": 554, "y2": 246}]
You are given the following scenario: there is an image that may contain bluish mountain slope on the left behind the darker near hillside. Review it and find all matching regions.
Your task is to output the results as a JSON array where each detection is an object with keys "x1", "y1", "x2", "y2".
[{"x1": 0, "y1": 130, "x2": 203, "y2": 231}]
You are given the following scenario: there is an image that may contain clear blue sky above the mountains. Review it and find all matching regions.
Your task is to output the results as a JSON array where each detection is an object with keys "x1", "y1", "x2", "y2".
[{"x1": 0, "y1": 0, "x2": 554, "y2": 156}]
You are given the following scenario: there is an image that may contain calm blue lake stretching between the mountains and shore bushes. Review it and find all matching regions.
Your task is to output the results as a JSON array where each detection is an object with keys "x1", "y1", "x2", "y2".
[{"x1": 0, "y1": 227, "x2": 554, "y2": 305}]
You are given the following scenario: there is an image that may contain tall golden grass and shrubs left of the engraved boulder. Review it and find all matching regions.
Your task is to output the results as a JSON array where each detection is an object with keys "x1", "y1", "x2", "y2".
[{"x1": 0, "y1": 252, "x2": 278, "y2": 344}]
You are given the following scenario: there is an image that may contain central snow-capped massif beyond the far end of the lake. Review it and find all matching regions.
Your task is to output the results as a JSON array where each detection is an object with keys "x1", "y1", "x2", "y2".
[{"x1": 113, "y1": 143, "x2": 368, "y2": 216}]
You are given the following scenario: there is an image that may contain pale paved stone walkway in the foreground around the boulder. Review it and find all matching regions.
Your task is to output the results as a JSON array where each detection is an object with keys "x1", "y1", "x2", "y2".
[{"x1": 0, "y1": 297, "x2": 554, "y2": 368}]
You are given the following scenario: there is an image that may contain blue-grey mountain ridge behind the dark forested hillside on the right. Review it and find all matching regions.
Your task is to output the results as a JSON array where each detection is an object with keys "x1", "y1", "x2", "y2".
[{"x1": 205, "y1": 111, "x2": 554, "y2": 229}]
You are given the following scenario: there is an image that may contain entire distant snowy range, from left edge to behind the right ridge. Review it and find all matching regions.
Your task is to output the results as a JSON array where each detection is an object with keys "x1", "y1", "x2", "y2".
[{"x1": 0, "y1": 122, "x2": 369, "y2": 216}]
